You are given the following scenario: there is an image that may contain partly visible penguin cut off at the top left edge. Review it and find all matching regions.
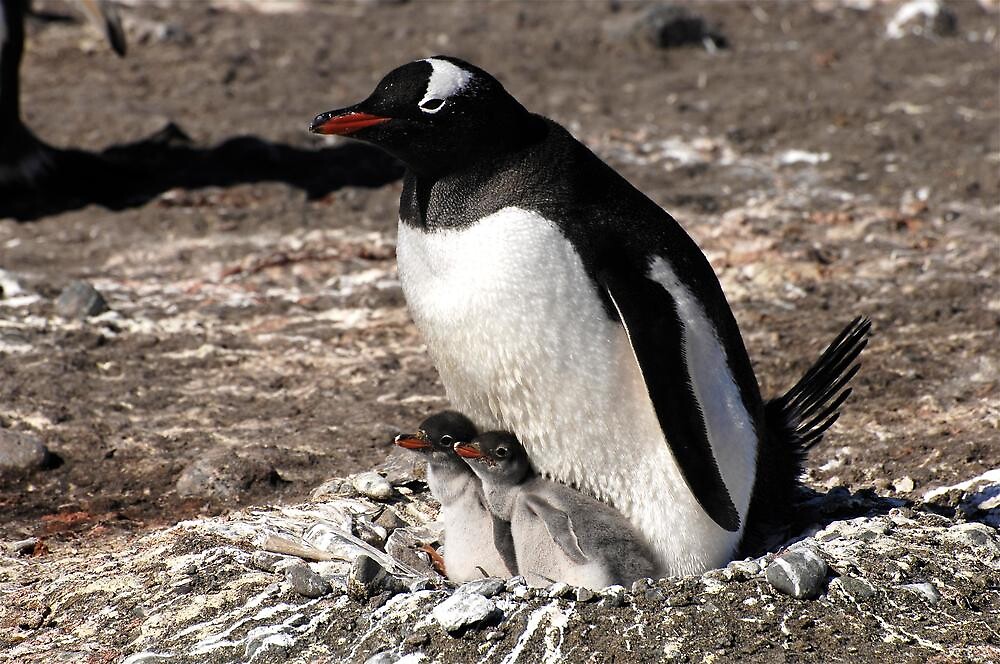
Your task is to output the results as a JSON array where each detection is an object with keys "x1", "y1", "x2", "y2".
[{"x1": 0, "y1": 0, "x2": 125, "y2": 188}]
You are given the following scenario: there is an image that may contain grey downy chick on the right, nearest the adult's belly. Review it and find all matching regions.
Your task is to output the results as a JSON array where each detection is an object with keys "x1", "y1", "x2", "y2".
[{"x1": 455, "y1": 431, "x2": 658, "y2": 588}]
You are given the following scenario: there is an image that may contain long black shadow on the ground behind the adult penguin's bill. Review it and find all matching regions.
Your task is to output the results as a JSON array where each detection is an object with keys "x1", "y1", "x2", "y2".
[{"x1": 0, "y1": 123, "x2": 403, "y2": 221}]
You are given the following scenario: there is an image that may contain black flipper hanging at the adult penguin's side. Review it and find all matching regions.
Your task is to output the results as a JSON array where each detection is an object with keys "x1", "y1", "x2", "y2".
[{"x1": 597, "y1": 268, "x2": 740, "y2": 532}]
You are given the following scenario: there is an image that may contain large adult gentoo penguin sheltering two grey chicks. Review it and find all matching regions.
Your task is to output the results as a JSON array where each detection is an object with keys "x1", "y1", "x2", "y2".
[{"x1": 311, "y1": 56, "x2": 872, "y2": 574}]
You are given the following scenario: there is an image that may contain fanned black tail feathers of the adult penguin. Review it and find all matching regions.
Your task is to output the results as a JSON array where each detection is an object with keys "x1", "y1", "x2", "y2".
[{"x1": 764, "y1": 316, "x2": 872, "y2": 466}]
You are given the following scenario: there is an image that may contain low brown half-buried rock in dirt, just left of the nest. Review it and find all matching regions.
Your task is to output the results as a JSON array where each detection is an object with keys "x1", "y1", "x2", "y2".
[{"x1": 176, "y1": 450, "x2": 281, "y2": 500}]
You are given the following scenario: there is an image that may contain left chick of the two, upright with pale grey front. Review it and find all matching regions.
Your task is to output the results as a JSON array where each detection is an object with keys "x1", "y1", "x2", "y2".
[{"x1": 395, "y1": 411, "x2": 517, "y2": 582}]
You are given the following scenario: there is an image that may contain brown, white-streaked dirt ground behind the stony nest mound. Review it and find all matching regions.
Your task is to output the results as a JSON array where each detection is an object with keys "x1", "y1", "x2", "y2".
[{"x1": 0, "y1": 0, "x2": 1000, "y2": 551}]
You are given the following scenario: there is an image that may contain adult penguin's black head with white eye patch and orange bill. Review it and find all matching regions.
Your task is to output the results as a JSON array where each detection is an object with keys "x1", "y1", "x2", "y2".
[{"x1": 309, "y1": 55, "x2": 534, "y2": 175}]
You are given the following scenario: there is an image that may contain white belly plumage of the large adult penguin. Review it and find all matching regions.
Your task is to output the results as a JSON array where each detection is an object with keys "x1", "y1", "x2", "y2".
[{"x1": 397, "y1": 208, "x2": 756, "y2": 574}]
